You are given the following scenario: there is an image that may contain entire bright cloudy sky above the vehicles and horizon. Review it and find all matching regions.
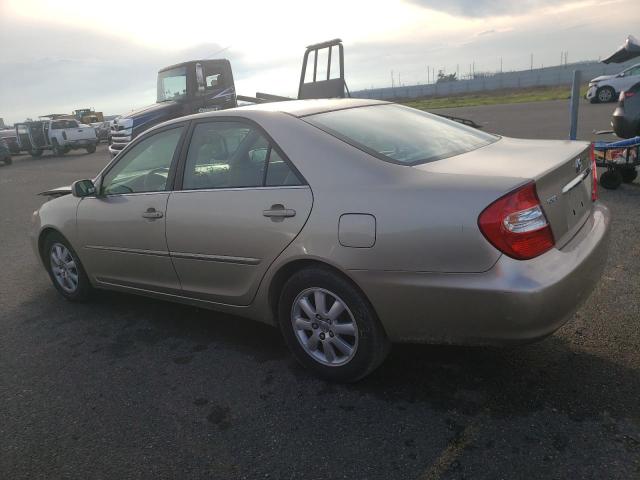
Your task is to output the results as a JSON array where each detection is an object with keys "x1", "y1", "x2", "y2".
[{"x1": 0, "y1": 0, "x2": 640, "y2": 122}]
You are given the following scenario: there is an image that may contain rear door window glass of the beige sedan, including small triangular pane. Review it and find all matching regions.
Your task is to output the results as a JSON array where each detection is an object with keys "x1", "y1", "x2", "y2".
[{"x1": 183, "y1": 121, "x2": 300, "y2": 190}]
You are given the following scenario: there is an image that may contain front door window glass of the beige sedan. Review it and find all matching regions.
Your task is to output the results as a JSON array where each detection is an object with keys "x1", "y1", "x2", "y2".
[{"x1": 102, "y1": 127, "x2": 183, "y2": 195}]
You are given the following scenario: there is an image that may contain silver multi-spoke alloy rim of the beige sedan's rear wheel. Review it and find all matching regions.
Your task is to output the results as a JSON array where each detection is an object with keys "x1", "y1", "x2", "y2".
[{"x1": 291, "y1": 287, "x2": 358, "y2": 367}]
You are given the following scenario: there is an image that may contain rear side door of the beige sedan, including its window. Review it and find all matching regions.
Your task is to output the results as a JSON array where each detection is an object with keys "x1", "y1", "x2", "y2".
[{"x1": 167, "y1": 119, "x2": 312, "y2": 305}]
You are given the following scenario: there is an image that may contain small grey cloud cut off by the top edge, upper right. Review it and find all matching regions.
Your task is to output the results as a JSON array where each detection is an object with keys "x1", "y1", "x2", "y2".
[{"x1": 408, "y1": 0, "x2": 571, "y2": 18}]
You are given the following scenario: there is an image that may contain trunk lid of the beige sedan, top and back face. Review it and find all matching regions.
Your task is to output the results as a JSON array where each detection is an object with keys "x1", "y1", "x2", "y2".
[{"x1": 417, "y1": 138, "x2": 593, "y2": 248}]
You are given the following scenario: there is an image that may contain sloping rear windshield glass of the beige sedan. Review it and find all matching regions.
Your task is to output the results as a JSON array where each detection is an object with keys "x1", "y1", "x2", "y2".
[{"x1": 304, "y1": 104, "x2": 499, "y2": 165}]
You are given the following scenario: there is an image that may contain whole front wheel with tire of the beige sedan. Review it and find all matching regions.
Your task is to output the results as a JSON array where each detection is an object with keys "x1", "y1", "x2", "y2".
[{"x1": 42, "y1": 233, "x2": 93, "y2": 302}]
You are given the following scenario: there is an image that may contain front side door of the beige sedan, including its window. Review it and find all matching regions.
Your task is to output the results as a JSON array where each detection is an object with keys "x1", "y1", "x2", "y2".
[{"x1": 77, "y1": 126, "x2": 184, "y2": 293}]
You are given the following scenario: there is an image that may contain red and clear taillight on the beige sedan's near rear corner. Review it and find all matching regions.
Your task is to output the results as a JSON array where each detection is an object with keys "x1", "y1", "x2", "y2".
[{"x1": 478, "y1": 182, "x2": 554, "y2": 260}]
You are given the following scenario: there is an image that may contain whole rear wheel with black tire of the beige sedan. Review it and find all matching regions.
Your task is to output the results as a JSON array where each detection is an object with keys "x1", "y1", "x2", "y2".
[{"x1": 278, "y1": 267, "x2": 390, "y2": 382}]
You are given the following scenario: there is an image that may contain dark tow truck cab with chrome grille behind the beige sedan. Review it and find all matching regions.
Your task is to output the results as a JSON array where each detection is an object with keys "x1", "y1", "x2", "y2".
[{"x1": 109, "y1": 59, "x2": 237, "y2": 156}]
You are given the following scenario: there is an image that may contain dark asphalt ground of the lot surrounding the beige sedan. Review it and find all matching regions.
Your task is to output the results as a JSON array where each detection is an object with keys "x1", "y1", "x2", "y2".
[{"x1": 0, "y1": 102, "x2": 640, "y2": 480}]
